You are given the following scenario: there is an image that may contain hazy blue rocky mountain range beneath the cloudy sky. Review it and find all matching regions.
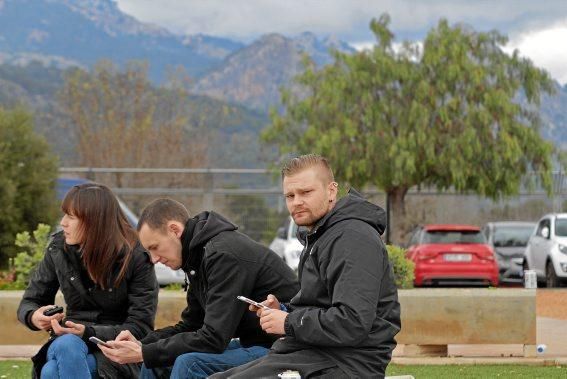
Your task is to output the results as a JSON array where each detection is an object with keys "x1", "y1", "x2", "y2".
[{"x1": 0, "y1": 0, "x2": 567, "y2": 159}]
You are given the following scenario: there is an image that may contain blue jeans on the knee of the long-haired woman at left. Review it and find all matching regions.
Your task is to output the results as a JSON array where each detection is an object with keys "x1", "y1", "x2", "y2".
[{"x1": 41, "y1": 334, "x2": 98, "y2": 379}]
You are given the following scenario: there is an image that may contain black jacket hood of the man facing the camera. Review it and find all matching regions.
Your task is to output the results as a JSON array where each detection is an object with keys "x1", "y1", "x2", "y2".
[{"x1": 299, "y1": 188, "x2": 386, "y2": 245}]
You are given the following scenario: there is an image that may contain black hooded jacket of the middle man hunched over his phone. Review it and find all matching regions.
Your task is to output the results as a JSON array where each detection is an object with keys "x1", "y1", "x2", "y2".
[{"x1": 142, "y1": 212, "x2": 298, "y2": 368}]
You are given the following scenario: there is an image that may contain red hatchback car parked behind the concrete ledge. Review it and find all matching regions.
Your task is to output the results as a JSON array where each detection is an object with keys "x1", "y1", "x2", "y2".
[{"x1": 406, "y1": 225, "x2": 498, "y2": 287}]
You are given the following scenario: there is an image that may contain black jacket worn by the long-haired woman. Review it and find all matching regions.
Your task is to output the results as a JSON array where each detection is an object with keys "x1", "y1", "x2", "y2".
[{"x1": 18, "y1": 232, "x2": 158, "y2": 377}]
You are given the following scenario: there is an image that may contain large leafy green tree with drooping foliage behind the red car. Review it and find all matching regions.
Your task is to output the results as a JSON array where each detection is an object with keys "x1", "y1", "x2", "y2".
[{"x1": 263, "y1": 15, "x2": 553, "y2": 242}]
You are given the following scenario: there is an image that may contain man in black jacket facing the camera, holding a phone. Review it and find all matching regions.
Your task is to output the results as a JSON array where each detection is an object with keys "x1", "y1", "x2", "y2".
[{"x1": 213, "y1": 155, "x2": 400, "y2": 378}]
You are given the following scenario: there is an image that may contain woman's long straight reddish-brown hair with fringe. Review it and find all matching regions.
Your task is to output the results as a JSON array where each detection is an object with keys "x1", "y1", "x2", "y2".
[{"x1": 61, "y1": 183, "x2": 137, "y2": 289}]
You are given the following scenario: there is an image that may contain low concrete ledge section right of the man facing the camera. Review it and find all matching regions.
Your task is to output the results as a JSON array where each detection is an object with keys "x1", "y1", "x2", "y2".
[{"x1": 396, "y1": 288, "x2": 536, "y2": 345}]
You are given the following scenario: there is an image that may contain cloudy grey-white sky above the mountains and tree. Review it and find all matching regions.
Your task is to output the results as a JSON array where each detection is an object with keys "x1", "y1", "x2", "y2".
[{"x1": 117, "y1": 0, "x2": 567, "y2": 84}]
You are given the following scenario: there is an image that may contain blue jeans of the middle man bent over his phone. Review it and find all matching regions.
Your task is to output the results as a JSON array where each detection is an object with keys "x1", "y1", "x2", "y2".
[{"x1": 140, "y1": 339, "x2": 269, "y2": 379}]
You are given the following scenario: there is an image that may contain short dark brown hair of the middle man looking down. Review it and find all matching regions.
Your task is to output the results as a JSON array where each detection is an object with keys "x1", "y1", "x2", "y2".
[{"x1": 137, "y1": 198, "x2": 189, "y2": 231}]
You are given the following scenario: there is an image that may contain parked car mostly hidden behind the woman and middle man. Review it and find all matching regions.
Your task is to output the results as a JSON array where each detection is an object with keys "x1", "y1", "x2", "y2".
[{"x1": 56, "y1": 178, "x2": 185, "y2": 286}]
